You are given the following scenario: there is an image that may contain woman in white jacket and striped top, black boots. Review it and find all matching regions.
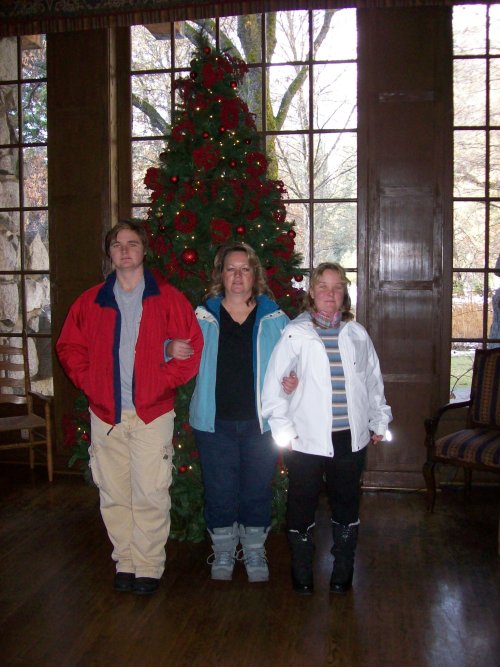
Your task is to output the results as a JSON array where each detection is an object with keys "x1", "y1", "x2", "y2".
[{"x1": 262, "y1": 262, "x2": 392, "y2": 595}]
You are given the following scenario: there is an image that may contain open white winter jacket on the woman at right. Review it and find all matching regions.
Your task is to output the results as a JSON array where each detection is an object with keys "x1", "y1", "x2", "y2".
[{"x1": 262, "y1": 312, "x2": 392, "y2": 456}]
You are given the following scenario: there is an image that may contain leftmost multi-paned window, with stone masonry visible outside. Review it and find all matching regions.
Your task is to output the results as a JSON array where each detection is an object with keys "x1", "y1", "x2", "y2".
[{"x1": 0, "y1": 35, "x2": 53, "y2": 395}]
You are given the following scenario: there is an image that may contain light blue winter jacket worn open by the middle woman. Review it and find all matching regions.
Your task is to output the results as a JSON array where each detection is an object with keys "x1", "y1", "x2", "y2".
[{"x1": 189, "y1": 294, "x2": 289, "y2": 433}]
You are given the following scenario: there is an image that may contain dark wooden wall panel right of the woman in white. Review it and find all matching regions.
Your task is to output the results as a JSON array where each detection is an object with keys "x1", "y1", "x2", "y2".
[{"x1": 358, "y1": 7, "x2": 452, "y2": 488}]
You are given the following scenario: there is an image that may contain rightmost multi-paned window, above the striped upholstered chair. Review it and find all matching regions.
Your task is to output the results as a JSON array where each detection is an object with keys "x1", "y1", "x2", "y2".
[{"x1": 450, "y1": 5, "x2": 500, "y2": 400}]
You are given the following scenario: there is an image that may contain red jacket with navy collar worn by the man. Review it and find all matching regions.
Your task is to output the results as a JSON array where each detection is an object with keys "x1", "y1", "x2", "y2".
[{"x1": 56, "y1": 269, "x2": 203, "y2": 424}]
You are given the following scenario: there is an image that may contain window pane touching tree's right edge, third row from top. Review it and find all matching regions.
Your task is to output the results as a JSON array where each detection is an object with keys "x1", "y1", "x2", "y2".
[{"x1": 274, "y1": 134, "x2": 309, "y2": 199}]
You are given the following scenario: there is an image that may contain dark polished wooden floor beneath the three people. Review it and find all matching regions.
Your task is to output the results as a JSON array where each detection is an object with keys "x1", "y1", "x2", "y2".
[{"x1": 0, "y1": 466, "x2": 500, "y2": 667}]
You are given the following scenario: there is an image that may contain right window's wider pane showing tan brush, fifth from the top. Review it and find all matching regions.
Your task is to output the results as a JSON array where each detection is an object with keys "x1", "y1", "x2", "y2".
[{"x1": 452, "y1": 271, "x2": 484, "y2": 338}]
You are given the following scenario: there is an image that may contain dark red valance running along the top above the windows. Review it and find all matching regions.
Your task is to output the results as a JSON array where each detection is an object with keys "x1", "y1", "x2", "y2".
[{"x1": 0, "y1": 0, "x2": 484, "y2": 37}]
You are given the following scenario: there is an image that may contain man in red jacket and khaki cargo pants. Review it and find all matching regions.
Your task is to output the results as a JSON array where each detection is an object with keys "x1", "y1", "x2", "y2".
[{"x1": 56, "y1": 221, "x2": 203, "y2": 594}]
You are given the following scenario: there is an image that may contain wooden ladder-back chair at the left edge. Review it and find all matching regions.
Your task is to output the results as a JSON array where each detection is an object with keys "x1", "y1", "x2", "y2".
[{"x1": 0, "y1": 334, "x2": 53, "y2": 482}]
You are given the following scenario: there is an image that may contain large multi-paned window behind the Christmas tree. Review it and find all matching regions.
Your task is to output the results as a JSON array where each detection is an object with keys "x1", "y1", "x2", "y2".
[{"x1": 131, "y1": 9, "x2": 357, "y2": 303}]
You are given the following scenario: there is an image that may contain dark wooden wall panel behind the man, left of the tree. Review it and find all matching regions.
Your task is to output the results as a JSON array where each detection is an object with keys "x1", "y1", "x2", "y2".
[{"x1": 47, "y1": 30, "x2": 121, "y2": 466}]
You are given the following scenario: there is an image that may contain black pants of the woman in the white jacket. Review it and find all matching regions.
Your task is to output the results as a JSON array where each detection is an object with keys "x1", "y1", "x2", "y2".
[{"x1": 285, "y1": 431, "x2": 366, "y2": 533}]
